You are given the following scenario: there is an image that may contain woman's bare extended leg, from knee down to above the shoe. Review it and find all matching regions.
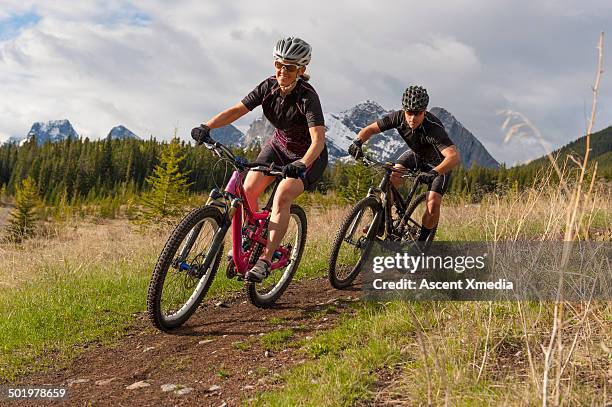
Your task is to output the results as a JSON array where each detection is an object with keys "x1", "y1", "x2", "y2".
[{"x1": 260, "y1": 178, "x2": 304, "y2": 261}]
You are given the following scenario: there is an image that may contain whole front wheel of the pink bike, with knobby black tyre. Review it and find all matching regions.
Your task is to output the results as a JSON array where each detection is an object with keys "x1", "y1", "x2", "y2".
[{"x1": 147, "y1": 206, "x2": 223, "y2": 331}]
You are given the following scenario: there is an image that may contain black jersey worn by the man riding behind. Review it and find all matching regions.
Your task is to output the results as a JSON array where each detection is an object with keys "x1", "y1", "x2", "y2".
[{"x1": 376, "y1": 110, "x2": 454, "y2": 166}]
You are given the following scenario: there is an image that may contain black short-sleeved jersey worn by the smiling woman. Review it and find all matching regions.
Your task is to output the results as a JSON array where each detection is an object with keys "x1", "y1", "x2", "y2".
[{"x1": 242, "y1": 76, "x2": 325, "y2": 159}]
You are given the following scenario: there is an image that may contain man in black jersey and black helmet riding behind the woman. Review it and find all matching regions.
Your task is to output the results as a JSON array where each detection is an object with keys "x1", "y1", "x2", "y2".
[{"x1": 348, "y1": 86, "x2": 460, "y2": 241}]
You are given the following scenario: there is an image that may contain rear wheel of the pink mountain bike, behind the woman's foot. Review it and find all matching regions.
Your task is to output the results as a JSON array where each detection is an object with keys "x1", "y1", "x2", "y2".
[{"x1": 246, "y1": 205, "x2": 307, "y2": 308}]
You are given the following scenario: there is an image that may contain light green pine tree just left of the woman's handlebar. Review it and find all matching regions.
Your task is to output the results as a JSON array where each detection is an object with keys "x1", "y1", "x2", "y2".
[{"x1": 140, "y1": 138, "x2": 191, "y2": 223}]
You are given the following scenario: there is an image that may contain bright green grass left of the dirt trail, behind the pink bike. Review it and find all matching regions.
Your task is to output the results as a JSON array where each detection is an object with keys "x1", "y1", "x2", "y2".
[{"x1": 0, "y1": 233, "x2": 332, "y2": 382}]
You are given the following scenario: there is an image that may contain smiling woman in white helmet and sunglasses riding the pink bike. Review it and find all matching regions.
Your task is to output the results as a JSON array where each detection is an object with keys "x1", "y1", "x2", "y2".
[{"x1": 191, "y1": 37, "x2": 327, "y2": 282}]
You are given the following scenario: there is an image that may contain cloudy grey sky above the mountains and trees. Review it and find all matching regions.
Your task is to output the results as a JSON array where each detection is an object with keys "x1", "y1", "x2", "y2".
[{"x1": 0, "y1": 0, "x2": 612, "y2": 164}]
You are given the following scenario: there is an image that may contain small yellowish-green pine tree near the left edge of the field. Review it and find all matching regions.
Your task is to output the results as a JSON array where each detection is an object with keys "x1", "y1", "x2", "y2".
[{"x1": 7, "y1": 177, "x2": 40, "y2": 243}]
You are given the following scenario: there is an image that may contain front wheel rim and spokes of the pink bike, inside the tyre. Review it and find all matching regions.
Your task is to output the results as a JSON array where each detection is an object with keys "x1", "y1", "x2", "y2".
[{"x1": 160, "y1": 218, "x2": 219, "y2": 322}]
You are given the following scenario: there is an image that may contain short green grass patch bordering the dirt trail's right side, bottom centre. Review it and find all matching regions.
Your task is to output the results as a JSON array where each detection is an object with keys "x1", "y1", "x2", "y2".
[{"x1": 254, "y1": 304, "x2": 409, "y2": 406}]
